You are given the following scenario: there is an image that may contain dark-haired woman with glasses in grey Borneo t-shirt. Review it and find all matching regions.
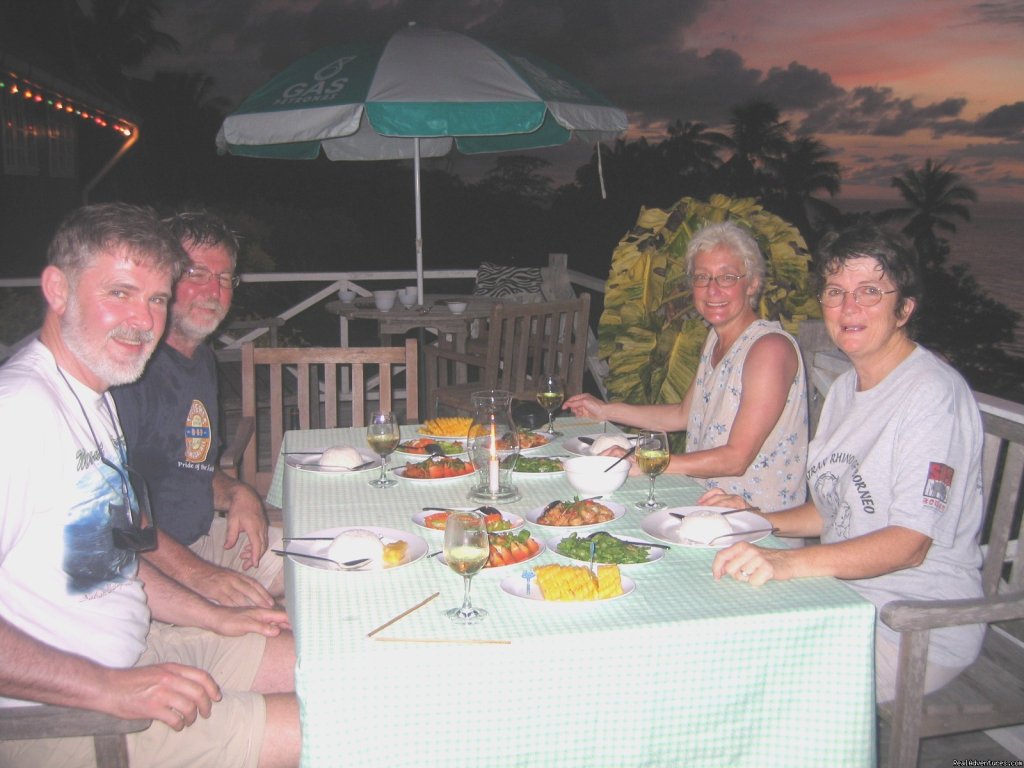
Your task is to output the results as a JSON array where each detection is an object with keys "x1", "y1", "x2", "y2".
[{"x1": 700, "y1": 222, "x2": 984, "y2": 701}]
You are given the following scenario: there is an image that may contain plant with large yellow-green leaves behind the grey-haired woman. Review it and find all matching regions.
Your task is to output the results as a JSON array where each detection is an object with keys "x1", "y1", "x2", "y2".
[{"x1": 598, "y1": 195, "x2": 821, "y2": 428}]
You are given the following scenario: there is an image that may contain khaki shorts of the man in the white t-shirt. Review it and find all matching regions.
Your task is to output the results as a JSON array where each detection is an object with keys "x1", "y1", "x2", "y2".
[{"x1": 0, "y1": 623, "x2": 266, "y2": 768}]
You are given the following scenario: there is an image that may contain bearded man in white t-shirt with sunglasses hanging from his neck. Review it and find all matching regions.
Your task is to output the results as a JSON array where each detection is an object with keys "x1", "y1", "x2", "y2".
[{"x1": 0, "y1": 204, "x2": 300, "y2": 768}]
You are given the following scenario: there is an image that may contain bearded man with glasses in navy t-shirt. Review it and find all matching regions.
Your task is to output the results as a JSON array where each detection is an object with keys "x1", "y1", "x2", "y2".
[{"x1": 112, "y1": 211, "x2": 284, "y2": 607}]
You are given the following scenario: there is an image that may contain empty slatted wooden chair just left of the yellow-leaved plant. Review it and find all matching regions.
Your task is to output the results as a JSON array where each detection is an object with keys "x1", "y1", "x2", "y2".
[{"x1": 424, "y1": 294, "x2": 590, "y2": 417}]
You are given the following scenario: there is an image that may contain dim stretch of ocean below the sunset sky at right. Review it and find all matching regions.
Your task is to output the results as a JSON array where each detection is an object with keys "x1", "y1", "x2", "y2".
[{"x1": 839, "y1": 200, "x2": 1024, "y2": 356}]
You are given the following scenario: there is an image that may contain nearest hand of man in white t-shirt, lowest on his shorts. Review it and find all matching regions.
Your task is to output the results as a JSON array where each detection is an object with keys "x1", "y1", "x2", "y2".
[{"x1": 99, "y1": 664, "x2": 220, "y2": 731}]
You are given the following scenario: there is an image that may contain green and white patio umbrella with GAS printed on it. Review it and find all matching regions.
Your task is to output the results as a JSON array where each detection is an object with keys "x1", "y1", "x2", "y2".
[{"x1": 217, "y1": 25, "x2": 628, "y2": 303}]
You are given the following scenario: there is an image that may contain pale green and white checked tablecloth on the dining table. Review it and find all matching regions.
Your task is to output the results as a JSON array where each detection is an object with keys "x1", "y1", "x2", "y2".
[{"x1": 268, "y1": 418, "x2": 876, "y2": 768}]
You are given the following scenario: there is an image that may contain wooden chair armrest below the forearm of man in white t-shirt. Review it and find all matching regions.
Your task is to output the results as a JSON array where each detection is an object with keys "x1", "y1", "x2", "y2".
[{"x1": 0, "y1": 705, "x2": 153, "y2": 768}]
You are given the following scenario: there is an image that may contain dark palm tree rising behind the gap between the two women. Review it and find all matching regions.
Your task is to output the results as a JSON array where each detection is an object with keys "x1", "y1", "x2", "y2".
[{"x1": 767, "y1": 136, "x2": 841, "y2": 242}]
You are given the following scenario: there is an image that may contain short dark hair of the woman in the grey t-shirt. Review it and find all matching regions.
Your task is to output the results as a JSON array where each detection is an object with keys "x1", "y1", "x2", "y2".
[{"x1": 813, "y1": 216, "x2": 924, "y2": 335}]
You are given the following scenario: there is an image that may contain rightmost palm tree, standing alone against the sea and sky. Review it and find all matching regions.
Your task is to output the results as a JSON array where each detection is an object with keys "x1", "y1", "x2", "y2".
[{"x1": 881, "y1": 158, "x2": 978, "y2": 264}]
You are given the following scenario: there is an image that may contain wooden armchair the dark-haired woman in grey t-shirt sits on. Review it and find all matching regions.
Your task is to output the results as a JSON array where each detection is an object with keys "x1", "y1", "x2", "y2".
[{"x1": 879, "y1": 395, "x2": 1024, "y2": 768}]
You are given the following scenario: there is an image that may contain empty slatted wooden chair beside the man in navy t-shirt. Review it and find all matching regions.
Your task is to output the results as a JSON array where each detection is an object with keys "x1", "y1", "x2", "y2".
[{"x1": 237, "y1": 339, "x2": 420, "y2": 496}]
